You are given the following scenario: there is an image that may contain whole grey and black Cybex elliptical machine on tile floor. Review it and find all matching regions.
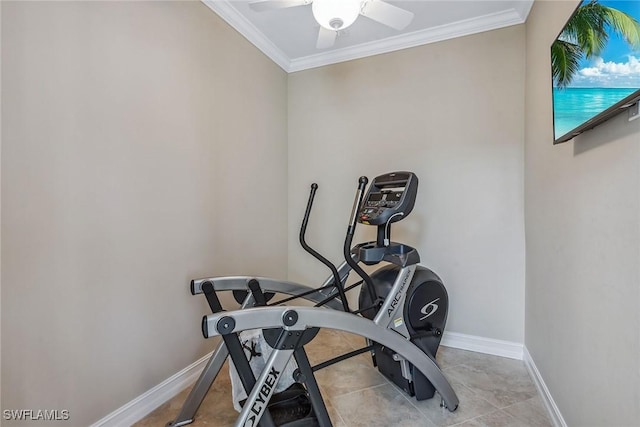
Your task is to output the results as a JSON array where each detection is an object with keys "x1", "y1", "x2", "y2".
[{"x1": 168, "y1": 172, "x2": 459, "y2": 427}]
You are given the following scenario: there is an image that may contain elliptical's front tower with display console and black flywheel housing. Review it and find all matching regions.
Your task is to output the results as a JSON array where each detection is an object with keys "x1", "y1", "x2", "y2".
[{"x1": 351, "y1": 172, "x2": 449, "y2": 400}]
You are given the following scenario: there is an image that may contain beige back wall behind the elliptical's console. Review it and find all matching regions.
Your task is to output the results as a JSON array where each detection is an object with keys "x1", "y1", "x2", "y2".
[{"x1": 289, "y1": 26, "x2": 525, "y2": 343}]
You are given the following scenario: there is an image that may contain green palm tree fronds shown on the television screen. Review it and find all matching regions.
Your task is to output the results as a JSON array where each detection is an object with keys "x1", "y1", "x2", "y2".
[{"x1": 551, "y1": 0, "x2": 640, "y2": 88}]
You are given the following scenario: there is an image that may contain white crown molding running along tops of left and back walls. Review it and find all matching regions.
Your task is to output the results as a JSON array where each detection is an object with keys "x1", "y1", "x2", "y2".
[{"x1": 201, "y1": 0, "x2": 533, "y2": 73}]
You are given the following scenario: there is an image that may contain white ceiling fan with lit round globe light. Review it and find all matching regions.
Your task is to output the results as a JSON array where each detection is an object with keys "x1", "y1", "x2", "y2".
[{"x1": 249, "y1": 0, "x2": 413, "y2": 49}]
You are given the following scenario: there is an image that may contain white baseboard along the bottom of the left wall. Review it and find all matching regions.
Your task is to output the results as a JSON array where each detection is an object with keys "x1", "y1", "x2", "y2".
[{"x1": 90, "y1": 353, "x2": 212, "y2": 427}]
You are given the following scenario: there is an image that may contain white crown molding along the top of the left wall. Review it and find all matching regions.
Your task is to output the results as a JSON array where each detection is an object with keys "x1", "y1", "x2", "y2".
[{"x1": 201, "y1": 0, "x2": 291, "y2": 72}]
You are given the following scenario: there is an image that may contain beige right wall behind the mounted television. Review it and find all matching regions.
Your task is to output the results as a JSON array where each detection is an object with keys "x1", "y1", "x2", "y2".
[{"x1": 525, "y1": 1, "x2": 640, "y2": 426}]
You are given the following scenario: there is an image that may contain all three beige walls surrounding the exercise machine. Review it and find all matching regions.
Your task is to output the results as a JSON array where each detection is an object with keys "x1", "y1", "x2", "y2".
[{"x1": 6, "y1": 1, "x2": 640, "y2": 426}]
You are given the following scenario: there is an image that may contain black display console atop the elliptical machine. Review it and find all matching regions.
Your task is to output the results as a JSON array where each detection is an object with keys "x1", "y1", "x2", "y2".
[{"x1": 358, "y1": 172, "x2": 418, "y2": 225}]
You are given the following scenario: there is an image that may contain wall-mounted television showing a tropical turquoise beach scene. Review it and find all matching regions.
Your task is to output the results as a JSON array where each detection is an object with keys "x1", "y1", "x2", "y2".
[{"x1": 551, "y1": 0, "x2": 640, "y2": 144}]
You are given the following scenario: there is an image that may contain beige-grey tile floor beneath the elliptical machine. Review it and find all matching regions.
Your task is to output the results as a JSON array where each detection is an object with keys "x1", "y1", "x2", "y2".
[{"x1": 135, "y1": 330, "x2": 551, "y2": 427}]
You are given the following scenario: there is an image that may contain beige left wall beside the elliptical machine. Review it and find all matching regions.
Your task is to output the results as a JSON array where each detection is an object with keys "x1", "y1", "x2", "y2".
[{"x1": 1, "y1": 2, "x2": 287, "y2": 426}]
